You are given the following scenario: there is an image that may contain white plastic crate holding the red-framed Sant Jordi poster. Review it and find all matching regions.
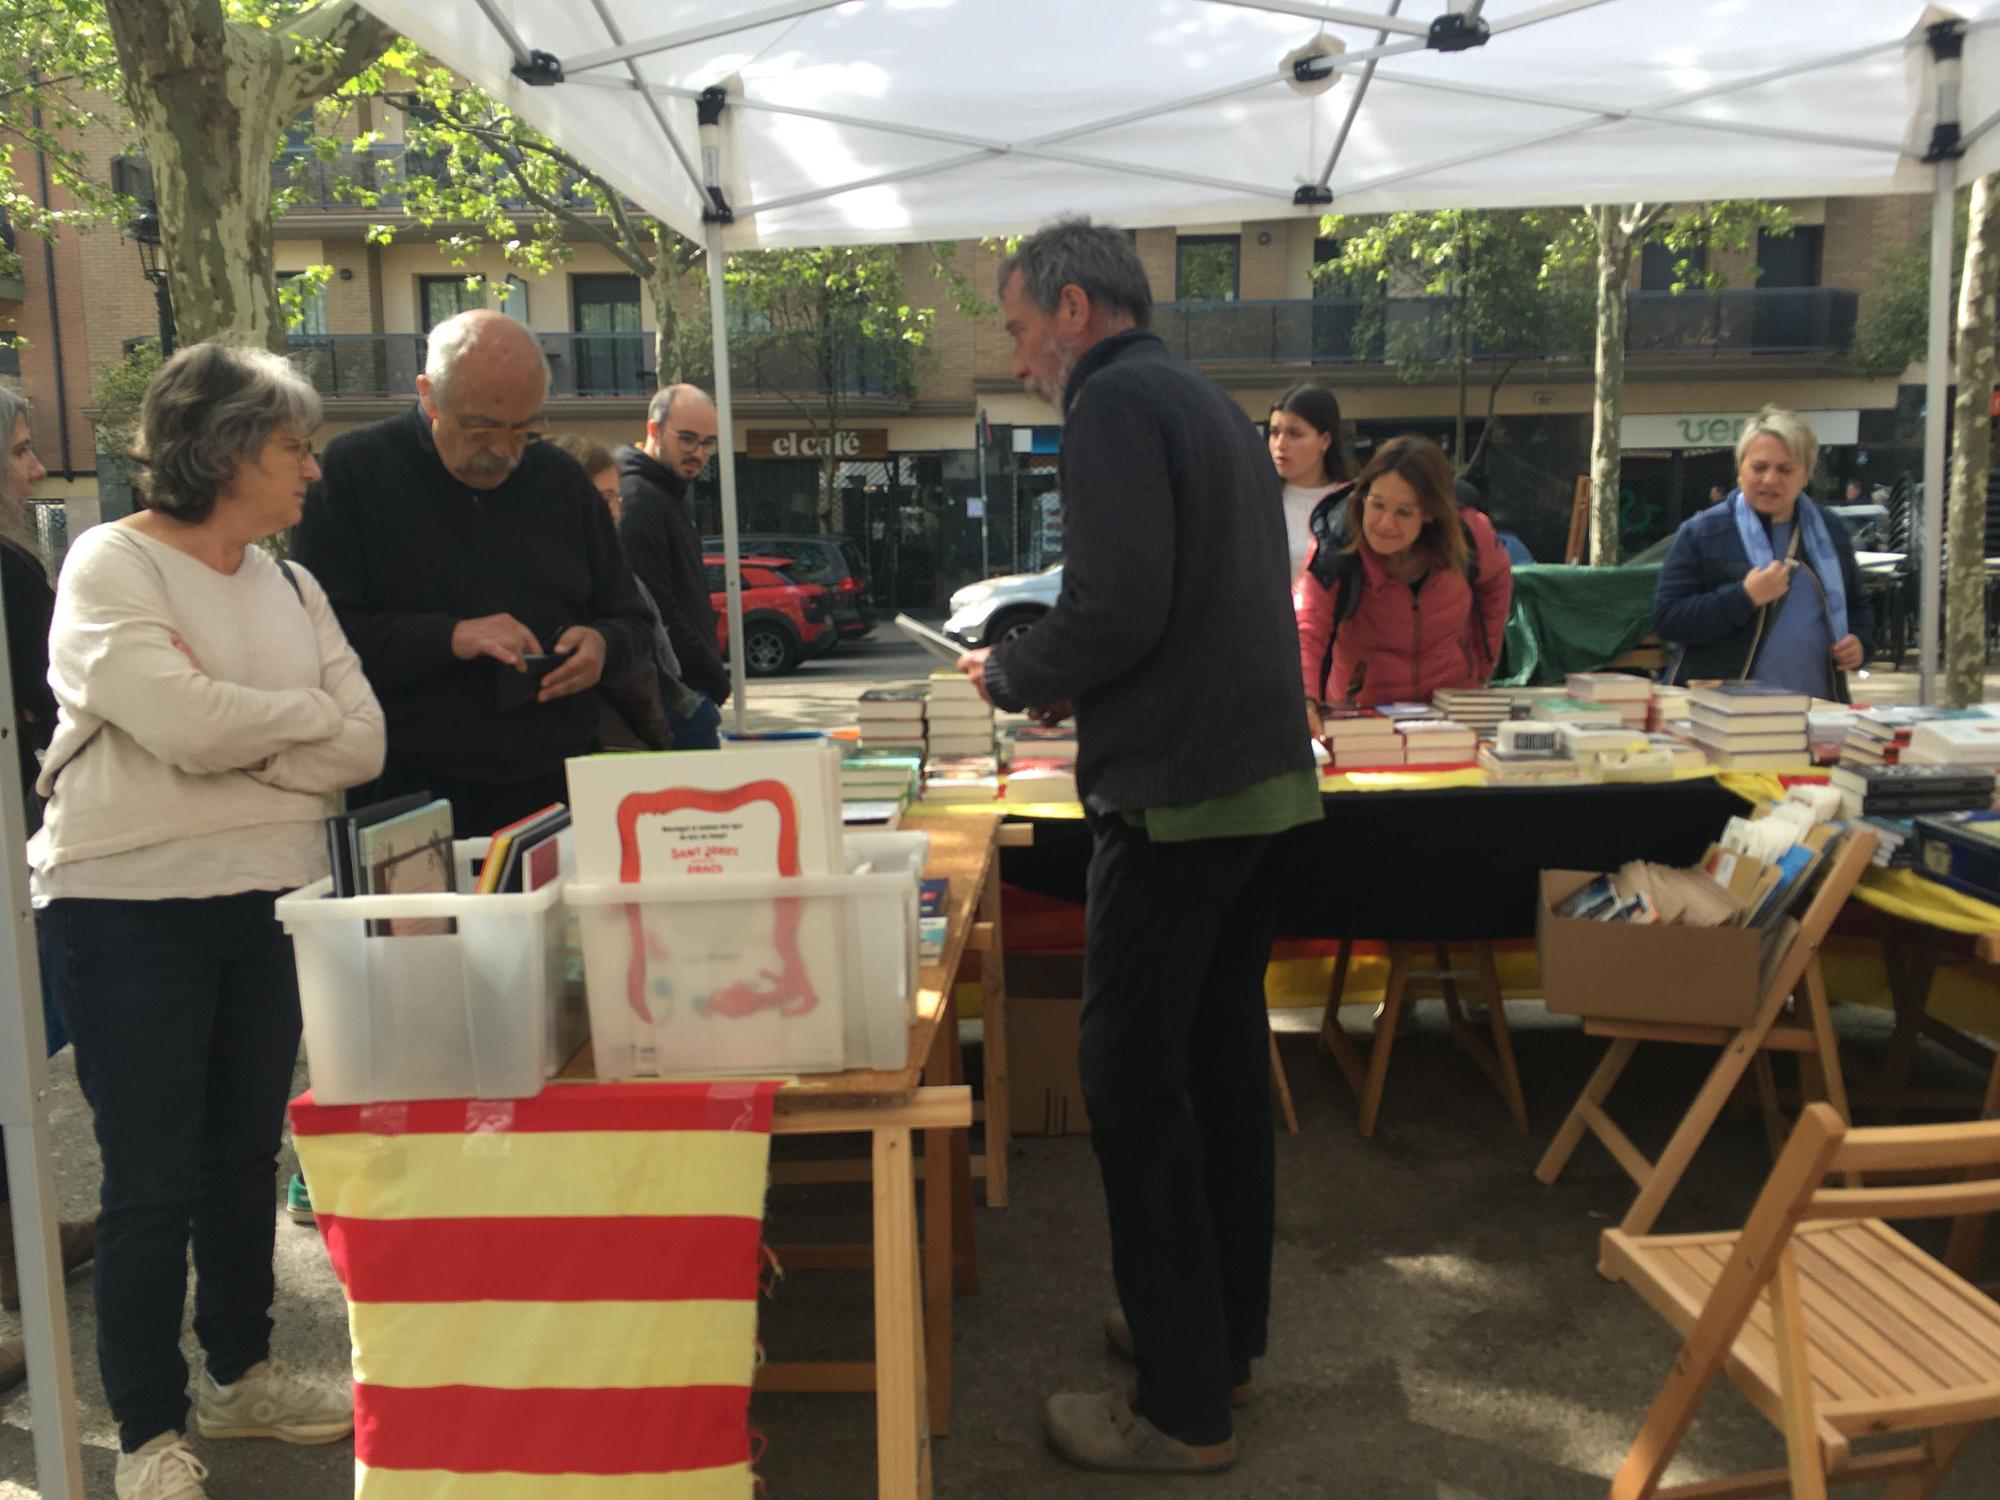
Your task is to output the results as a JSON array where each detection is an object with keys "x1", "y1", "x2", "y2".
[{"x1": 562, "y1": 832, "x2": 930, "y2": 1078}]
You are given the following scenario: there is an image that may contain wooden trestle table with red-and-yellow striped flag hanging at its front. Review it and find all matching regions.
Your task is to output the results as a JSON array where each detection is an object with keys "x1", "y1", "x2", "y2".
[{"x1": 562, "y1": 810, "x2": 1008, "y2": 1500}]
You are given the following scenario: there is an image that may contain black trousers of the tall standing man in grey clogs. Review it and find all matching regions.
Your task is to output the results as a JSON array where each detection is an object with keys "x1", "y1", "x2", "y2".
[{"x1": 1078, "y1": 814, "x2": 1276, "y2": 1444}]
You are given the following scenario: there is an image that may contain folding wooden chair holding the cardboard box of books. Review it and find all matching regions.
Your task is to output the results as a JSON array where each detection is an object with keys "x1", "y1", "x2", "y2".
[{"x1": 1534, "y1": 830, "x2": 1876, "y2": 1234}]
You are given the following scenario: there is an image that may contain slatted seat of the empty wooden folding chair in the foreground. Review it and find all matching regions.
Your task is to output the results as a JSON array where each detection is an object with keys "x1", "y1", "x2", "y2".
[{"x1": 1604, "y1": 1218, "x2": 2000, "y2": 1476}]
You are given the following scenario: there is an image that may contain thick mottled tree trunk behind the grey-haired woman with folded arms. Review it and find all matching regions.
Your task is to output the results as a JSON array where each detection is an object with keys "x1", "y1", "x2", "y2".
[{"x1": 104, "y1": 0, "x2": 396, "y2": 350}]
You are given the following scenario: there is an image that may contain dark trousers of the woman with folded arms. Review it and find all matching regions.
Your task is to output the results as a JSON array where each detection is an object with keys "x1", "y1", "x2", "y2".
[{"x1": 38, "y1": 892, "x2": 300, "y2": 1452}]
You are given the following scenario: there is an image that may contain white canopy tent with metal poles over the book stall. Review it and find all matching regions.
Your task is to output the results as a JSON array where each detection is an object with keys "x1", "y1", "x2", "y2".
[{"x1": 11, "y1": 0, "x2": 2000, "y2": 1498}]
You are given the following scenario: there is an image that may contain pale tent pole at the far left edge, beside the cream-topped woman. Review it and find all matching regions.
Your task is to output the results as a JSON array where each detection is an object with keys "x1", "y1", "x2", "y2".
[{"x1": 0, "y1": 580, "x2": 84, "y2": 1500}]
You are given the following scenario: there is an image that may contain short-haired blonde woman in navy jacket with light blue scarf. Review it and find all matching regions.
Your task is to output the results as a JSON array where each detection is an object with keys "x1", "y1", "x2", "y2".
[{"x1": 1652, "y1": 406, "x2": 1874, "y2": 702}]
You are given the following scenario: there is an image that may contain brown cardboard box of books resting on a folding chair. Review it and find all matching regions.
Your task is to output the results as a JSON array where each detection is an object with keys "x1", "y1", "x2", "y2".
[{"x1": 1534, "y1": 870, "x2": 1762, "y2": 1026}]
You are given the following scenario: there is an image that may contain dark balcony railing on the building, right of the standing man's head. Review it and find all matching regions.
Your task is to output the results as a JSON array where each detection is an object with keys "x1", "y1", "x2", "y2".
[{"x1": 1152, "y1": 286, "x2": 1860, "y2": 364}]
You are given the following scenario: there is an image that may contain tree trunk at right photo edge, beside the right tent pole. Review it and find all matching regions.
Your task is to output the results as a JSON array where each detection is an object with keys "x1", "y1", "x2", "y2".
[{"x1": 1944, "y1": 174, "x2": 2000, "y2": 708}]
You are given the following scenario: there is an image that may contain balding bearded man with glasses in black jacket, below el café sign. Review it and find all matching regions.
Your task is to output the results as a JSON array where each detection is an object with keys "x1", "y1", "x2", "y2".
[{"x1": 618, "y1": 386, "x2": 730, "y2": 750}]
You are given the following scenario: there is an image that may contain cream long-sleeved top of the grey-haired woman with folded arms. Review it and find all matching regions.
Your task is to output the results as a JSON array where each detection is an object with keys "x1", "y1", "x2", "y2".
[{"x1": 28, "y1": 524, "x2": 382, "y2": 906}]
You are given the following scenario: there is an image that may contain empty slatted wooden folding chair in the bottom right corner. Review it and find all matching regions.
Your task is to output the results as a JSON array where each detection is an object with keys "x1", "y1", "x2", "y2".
[{"x1": 1600, "y1": 1104, "x2": 2000, "y2": 1500}]
